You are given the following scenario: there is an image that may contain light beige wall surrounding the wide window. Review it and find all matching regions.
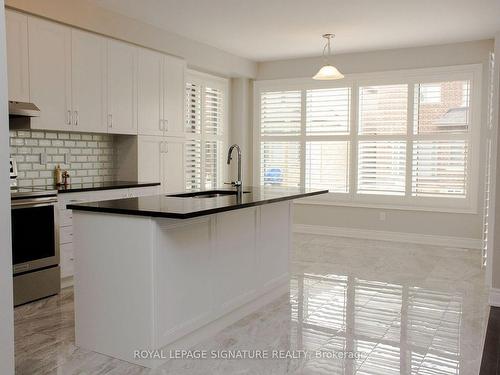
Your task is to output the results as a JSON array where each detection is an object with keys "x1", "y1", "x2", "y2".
[{"x1": 257, "y1": 40, "x2": 500, "y2": 242}]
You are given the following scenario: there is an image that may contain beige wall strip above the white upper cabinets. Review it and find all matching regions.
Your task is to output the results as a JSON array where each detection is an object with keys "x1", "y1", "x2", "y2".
[{"x1": 5, "y1": 0, "x2": 257, "y2": 77}]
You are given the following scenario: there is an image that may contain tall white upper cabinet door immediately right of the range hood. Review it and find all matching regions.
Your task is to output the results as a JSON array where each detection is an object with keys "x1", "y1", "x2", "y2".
[{"x1": 28, "y1": 17, "x2": 72, "y2": 130}]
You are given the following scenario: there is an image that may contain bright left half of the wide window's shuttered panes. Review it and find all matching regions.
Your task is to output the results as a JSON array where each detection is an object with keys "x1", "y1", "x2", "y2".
[{"x1": 260, "y1": 88, "x2": 350, "y2": 192}]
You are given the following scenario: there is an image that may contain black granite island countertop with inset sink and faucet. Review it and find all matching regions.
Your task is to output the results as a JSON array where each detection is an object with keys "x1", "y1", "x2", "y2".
[{"x1": 68, "y1": 186, "x2": 328, "y2": 219}]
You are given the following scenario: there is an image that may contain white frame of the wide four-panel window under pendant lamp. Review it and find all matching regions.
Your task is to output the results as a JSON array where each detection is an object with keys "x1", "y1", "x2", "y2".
[{"x1": 253, "y1": 64, "x2": 483, "y2": 213}]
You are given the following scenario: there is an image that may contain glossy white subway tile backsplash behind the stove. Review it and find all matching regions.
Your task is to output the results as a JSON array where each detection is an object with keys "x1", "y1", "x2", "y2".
[{"x1": 10, "y1": 130, "x2": 115, "y2": 186}]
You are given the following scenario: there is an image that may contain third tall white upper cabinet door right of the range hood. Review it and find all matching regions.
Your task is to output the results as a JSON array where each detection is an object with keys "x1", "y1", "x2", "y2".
[{"x1": 107, "y1": 39, "x2": 137, "y2": 134}]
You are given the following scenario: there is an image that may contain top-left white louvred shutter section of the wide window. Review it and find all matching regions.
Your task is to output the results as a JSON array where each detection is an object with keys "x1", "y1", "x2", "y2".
[{"x1": 260, "y1": 91, "x2": 301, "y2": 135}]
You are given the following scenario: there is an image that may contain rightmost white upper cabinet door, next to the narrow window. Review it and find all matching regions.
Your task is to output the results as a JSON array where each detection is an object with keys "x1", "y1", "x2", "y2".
[{"x1": 163, "y1": 56, "x2": 186, "y2": 136}]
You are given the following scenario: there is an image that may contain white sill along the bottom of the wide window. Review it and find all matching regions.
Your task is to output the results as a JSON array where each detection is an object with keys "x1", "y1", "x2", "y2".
[{"x1": 294, "y1": 197, "x2": 478, "y2": 215}]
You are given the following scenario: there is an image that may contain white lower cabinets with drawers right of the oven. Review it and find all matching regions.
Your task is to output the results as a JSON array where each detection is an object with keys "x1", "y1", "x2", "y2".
[{"x1": 59, "y1": 185, "x2": 159, "y2": 287}]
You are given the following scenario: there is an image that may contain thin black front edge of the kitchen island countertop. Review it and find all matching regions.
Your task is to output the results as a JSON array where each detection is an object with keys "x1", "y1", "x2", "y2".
[{"x1": 66, "y1": 190, "x2": 328, "y2": 219}]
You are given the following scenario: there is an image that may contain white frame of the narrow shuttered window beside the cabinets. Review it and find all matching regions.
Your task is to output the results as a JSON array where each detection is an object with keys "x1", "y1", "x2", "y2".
[{"x1": 183, "y1": 69, "x2": 230, "y2": 190}]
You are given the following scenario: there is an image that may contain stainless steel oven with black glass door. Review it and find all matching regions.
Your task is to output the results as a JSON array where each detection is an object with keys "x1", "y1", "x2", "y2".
[{"x1": 11, "y1": 190, "x2": 60, "y2": 306}]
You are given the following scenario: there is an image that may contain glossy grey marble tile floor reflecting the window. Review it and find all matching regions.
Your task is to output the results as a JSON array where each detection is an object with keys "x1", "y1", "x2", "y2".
[{"x1": 15, "y1": 235, "x2": 488, "y2": 375}]
